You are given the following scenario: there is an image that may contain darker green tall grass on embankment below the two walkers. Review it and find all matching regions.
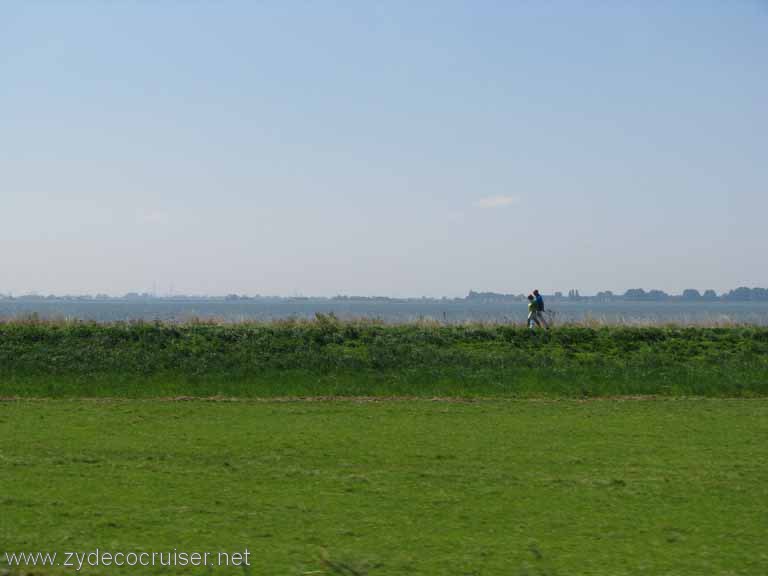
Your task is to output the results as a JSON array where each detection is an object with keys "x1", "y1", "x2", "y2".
[{"x1": 0, "y1": 316, "x2": 768, "y2": 397}]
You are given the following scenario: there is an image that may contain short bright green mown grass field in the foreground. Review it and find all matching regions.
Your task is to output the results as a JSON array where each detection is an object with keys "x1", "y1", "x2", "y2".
[{"x1": 0, "y1": 399, "x2": 768, "y2": 576}]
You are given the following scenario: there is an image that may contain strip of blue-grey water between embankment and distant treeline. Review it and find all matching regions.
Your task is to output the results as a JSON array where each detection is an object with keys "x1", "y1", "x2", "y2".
[{"x1": 0, "y1": 299, "x2": 768, "y2": 326}]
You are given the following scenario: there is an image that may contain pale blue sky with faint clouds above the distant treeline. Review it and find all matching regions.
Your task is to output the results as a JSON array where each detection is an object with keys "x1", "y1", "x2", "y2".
[{"x1": 0, "y1": 0, "x2": 768, "y2": 297}]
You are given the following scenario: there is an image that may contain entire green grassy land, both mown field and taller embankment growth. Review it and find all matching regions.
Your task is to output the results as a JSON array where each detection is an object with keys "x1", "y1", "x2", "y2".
[{"x1": 0, "y1": 316, "x2": 768, "y2": 576}]
